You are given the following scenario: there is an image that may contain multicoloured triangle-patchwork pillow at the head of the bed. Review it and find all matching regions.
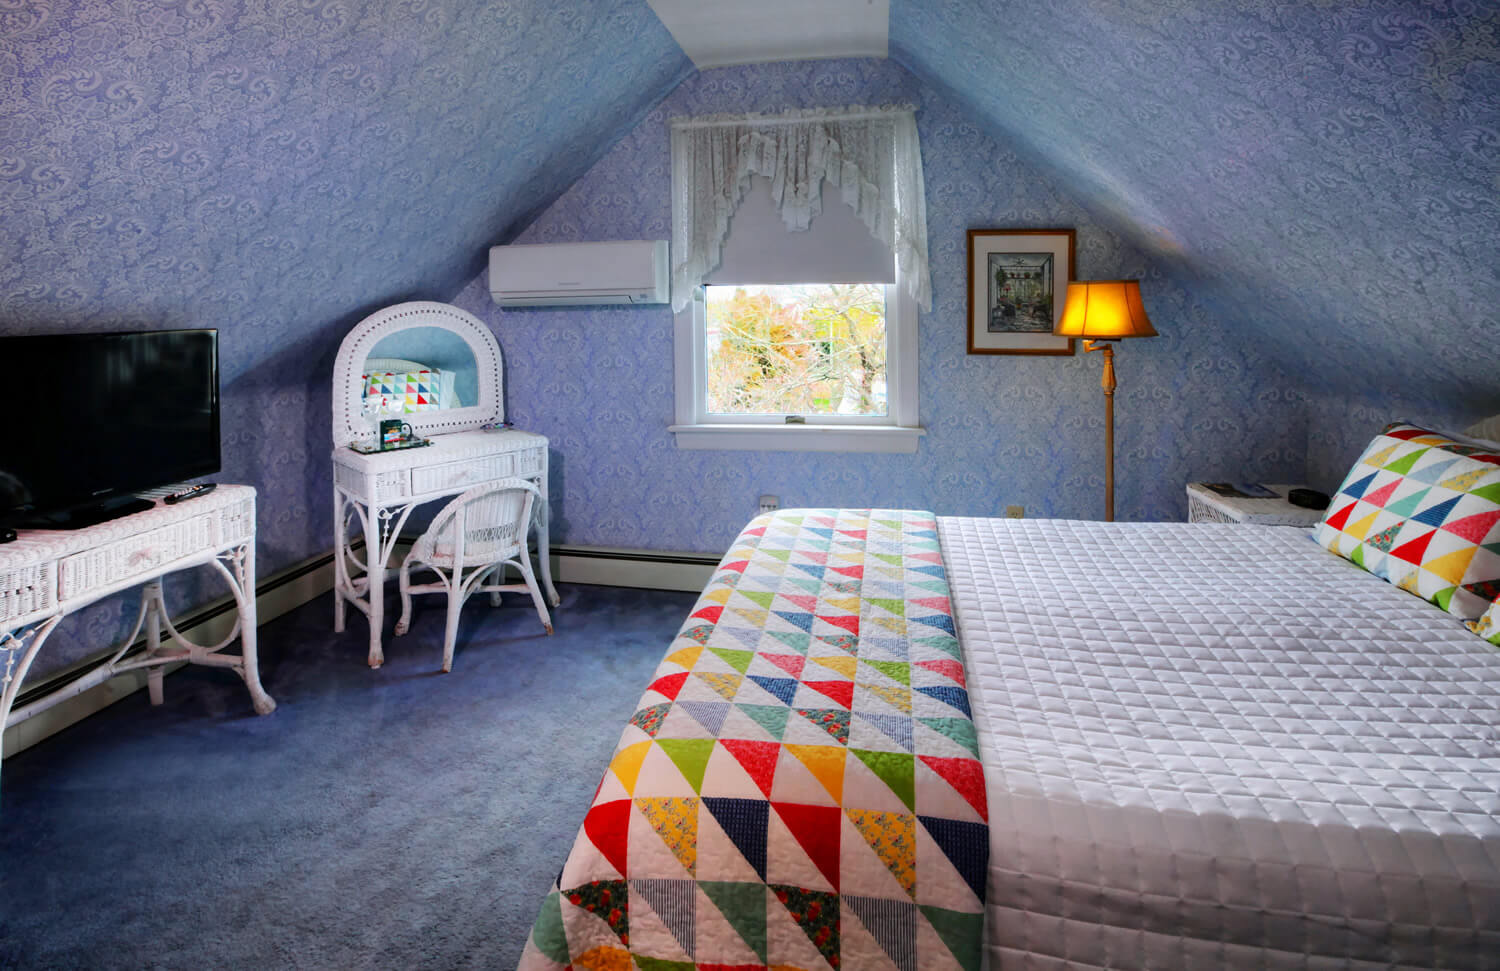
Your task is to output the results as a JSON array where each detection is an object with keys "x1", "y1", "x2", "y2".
[{"x1": 1313, "y1": 422, "x2": 1500, "y2": 620}]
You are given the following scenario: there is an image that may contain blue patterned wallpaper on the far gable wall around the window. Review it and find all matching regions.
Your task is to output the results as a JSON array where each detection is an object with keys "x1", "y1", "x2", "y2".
[{"x1": 456, "y1": 60, "x2": 1305, "y2": 551}]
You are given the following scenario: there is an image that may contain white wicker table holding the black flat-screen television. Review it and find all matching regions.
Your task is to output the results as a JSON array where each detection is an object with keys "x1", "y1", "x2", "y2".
[{"x1": 0, "y1": 485, "x2": 276, "y2": 774}]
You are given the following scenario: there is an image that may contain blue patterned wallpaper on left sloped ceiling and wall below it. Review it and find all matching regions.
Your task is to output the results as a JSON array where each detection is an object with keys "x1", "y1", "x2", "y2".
[{"x1": 0, "y1": 0, "x2": 692, "y2": 671}]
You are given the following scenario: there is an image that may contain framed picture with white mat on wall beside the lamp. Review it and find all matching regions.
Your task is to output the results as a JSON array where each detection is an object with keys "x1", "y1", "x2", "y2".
[{"x1": 969, "y1": 230, "x2": 1074, "y2": 356}]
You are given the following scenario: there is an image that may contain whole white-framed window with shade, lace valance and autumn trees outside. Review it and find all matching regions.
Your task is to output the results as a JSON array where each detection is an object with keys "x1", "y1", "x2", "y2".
[{"x1": 671, "y1": 108, "x2": 930, "y2": 452}]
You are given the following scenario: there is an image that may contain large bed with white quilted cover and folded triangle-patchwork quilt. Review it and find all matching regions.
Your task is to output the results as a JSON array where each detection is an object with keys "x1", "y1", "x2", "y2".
[{"x1": 522, "y1": 432, "x2": 1500, "y2": 971}]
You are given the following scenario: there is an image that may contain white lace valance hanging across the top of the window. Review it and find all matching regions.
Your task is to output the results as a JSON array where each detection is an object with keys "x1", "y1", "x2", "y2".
[{"x1": 672, "y1": 108, "x2": 932, "y2": 311}]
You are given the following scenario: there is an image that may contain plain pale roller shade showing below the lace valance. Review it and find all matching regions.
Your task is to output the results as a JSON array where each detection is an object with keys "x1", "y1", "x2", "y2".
[{"x1": 704, "y1": 176, "x2": 896, "y2": 284}]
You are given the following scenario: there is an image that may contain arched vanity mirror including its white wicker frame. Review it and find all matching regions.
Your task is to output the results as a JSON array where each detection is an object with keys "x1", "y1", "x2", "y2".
[{"x1": 333, "y1": 300, "x2": 506, "y2": 446}]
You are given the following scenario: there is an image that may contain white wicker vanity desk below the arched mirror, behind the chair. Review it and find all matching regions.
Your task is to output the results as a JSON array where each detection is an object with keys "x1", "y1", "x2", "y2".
[{"x1": 333, "y1": 429, "x2": 558, "y2": 668}]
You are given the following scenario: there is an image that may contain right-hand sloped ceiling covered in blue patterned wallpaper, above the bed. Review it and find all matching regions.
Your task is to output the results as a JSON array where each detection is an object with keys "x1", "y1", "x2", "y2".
[{"x1": 891, "y1": 0, "x2": 1500, "y2": 413}]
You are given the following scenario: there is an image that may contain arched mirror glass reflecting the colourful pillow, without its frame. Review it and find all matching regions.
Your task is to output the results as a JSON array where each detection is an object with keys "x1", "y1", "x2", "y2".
[{"x1": 362, "y1": 327, "x2": 479, "y2": 414}]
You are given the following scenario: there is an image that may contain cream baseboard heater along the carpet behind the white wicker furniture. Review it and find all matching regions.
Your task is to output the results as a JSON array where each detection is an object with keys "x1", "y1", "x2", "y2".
[{"x1": 3, "y1": 537, "x2": 719, "y2": 756}]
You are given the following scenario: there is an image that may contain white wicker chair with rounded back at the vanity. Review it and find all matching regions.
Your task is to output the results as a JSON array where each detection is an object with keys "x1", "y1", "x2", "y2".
[{"x1": 396, "y1": 479, "x2": 552, "y2": 671}]
